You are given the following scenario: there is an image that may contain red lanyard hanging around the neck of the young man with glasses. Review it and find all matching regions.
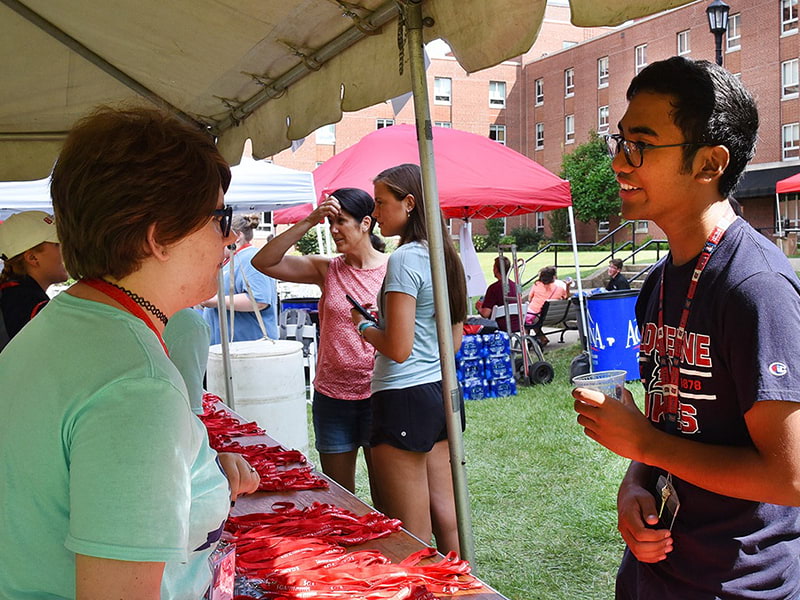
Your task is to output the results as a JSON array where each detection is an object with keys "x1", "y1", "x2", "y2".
[{"x1": 656, "y1": 218, "x2": 731, "y2": 431}]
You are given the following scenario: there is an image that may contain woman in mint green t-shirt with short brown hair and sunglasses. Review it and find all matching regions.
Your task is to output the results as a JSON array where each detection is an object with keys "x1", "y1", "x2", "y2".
[{"x1": 0, "y1": 108, "x2": 258, "y2": 600}]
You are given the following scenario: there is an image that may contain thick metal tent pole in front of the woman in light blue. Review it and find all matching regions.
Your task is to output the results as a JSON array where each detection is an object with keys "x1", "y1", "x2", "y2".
[{"x1": 403, "y1": 0, "x2": 475, "y2": 570}]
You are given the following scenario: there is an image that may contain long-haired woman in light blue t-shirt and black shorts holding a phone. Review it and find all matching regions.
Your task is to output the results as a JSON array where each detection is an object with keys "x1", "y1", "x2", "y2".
[{"x1": 351, "y1": 164, "x2": 467, "y2": 553}]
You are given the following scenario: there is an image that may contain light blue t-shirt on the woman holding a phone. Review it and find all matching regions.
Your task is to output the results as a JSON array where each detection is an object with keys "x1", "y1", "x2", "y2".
[{"x1": 372, "y1": 242, "x2": 442, "y2": 393}]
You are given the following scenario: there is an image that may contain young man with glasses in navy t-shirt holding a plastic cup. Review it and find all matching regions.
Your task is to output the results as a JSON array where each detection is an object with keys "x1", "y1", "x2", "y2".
[{"x1": 573, "y1": 57, "x2": 800, "y2": 600}]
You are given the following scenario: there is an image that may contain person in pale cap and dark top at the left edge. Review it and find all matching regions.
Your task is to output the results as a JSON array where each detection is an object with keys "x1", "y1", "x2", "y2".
[{"x1": 0, "y1": 210, "x2": 69, "y2": 349}]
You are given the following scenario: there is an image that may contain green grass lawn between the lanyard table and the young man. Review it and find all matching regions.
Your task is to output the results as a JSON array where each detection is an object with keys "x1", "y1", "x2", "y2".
[{"x1": 309, "y1": 346, "x2": 642, "y2": 600}]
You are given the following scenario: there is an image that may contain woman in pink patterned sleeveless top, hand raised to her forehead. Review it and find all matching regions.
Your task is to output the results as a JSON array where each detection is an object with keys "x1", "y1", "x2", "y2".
[{"x1": 253, "y1": 188, "x2": 387, "y2": 494}]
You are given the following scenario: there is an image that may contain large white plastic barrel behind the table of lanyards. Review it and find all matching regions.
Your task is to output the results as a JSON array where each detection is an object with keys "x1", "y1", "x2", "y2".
[{"x1": 207, "y1": 340, "x2": 308, "y2": 456}]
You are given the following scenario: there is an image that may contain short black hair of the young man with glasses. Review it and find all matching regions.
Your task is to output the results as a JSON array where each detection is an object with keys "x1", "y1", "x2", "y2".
[{"x1": 626, "y1": 56, "x2": 758, "y2": 197}]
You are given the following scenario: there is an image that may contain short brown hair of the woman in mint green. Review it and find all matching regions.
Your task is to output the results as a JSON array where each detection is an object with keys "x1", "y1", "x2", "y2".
[{"x1": 50, "y1": 107, "x2": 230, "y2": 279}]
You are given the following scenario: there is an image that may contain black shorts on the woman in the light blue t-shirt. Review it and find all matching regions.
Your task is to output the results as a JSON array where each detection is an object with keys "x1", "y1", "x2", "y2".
[{"x1": 369, "y1": 381, "x2": 466, "y2": 452}]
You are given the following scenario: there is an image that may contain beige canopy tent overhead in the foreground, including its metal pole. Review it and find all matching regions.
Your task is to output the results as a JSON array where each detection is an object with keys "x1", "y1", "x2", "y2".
[{"x1": 0, "y1": 0, "x2": 690, "y2": 563}]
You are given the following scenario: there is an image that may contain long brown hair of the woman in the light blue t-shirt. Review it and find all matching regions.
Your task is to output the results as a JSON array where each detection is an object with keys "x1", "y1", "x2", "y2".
[{"x1": 373, "y1": 163, "x2": 467, "y2": 325}]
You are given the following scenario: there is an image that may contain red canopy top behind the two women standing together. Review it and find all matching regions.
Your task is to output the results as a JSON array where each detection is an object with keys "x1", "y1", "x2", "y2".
[{"x1": 274, "y1": 125, "x2": 572, "y2": 223}]
